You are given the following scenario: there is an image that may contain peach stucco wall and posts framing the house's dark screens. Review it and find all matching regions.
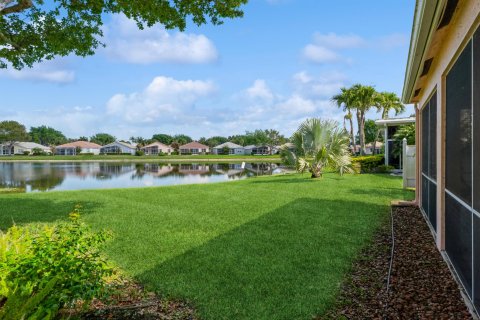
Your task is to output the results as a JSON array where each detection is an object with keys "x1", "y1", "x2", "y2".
[{"x1": 417, "y1": 0, "x2": 480, "y2": 250}]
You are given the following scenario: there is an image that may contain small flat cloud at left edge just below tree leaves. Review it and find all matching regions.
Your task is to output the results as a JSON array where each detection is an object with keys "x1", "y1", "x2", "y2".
[{"x1": 0, "y1": 57, "x2": 75, "y2": 84}]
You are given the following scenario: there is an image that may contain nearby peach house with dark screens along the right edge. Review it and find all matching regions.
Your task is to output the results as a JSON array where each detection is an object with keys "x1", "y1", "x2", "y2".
[{"x1": 402, "y1": 0, "x2": 480, "y2": 311}]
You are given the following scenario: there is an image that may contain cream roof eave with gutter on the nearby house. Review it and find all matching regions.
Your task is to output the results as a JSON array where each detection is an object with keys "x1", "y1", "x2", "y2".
[{"x1": 402, "y1": 0, "x2": 447, "y2": 103}]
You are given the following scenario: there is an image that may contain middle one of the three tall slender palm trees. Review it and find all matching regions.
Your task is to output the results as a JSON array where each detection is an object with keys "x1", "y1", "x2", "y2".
[{"x1": 349, "y1": 84, "x2": 378, "y2": 155}]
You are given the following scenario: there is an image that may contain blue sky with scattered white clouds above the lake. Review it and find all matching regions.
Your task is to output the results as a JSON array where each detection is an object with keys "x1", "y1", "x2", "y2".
[{"x1": 0, "y1": 0, "x2": 415, "y2": 139}]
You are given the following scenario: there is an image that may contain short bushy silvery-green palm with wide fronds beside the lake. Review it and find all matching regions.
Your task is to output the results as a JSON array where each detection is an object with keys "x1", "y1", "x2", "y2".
[{"x1": 281, "y1": 118, "x2": 353, "y2": 178}]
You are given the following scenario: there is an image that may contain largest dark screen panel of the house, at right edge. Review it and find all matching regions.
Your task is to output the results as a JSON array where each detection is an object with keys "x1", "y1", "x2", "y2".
[{"x1": 445, "y1": 30, "x2": 480, "y2": 309}]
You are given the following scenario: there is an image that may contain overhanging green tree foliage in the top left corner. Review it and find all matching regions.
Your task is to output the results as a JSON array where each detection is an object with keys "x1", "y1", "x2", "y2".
[{"x1": 0, "y1": 0, "x2": 247, "y2": 69}]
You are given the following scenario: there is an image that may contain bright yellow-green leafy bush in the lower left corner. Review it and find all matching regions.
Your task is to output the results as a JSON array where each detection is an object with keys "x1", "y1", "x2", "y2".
[{"x1": 0, "y1": 206, "x2": 113, "y2": 320}]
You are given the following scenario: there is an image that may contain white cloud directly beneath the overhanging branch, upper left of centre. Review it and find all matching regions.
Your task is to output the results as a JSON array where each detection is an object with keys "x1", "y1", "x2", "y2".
[{"x1": 105, "y1": 15, "x2": 218, "y2": 64}]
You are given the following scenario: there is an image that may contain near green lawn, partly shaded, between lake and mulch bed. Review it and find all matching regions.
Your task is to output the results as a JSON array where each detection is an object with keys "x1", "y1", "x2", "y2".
[{"x1": 0, "y1": 174, "x2": 413, "y2": 319}]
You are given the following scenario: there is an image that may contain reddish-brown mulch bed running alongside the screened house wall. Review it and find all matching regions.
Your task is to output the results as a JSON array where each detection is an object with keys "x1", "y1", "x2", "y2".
[{"x1": 322, "y1": 207, "x2": 472, "y2": 319}]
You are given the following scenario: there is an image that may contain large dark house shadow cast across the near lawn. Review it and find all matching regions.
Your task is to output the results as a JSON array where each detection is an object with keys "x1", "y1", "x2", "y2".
[{"x1": 137, "y1": 196, "x2": 388, "y2": 319}]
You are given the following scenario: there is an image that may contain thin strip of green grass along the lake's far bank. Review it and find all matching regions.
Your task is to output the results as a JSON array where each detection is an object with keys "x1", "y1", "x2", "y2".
[{"x1": 0, "y1": 154, "x2": 280, "y2": 162}]
